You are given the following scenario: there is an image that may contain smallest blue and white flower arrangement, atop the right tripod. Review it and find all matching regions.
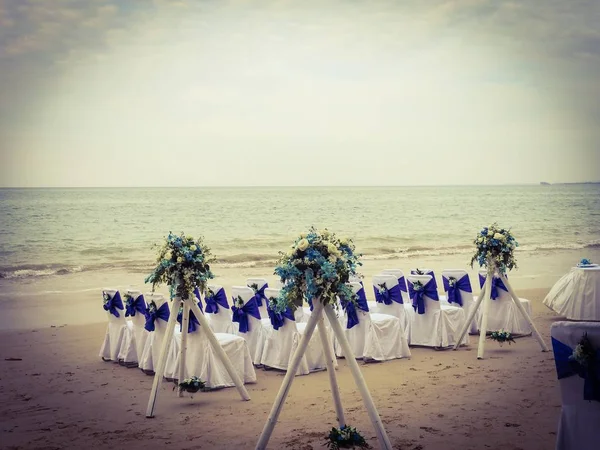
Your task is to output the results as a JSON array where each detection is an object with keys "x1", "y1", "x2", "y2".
[{"x1": 471, "y1": 223, "x2": 519, "y2": 273}]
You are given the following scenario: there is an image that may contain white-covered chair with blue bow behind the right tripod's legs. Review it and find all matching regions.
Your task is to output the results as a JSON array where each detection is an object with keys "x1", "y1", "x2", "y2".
[{"x1": 478, "y1": 269, "x2": 531, "y2": 335}]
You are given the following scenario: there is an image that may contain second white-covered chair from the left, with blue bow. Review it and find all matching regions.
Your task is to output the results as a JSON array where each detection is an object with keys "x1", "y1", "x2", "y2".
[{"x1": 119, "y1": 289, "x2": 148, "y2": 366}]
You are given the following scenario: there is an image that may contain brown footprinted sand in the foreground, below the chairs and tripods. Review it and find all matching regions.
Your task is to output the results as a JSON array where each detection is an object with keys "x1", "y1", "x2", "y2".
[{"x1": 0, "y1": 288, "x2": 560, "y2": 450}]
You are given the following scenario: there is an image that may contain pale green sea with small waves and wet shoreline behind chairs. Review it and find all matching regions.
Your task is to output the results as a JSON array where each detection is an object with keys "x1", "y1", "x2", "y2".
[{"x1": 0, "y1": 183, "x2": 600, "y2": 328}]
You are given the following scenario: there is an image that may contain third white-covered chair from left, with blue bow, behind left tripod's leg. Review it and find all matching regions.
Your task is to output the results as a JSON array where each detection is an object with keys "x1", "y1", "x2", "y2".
[{"x1": 138, "y1": 293, "x2": 179, "y2": 378}]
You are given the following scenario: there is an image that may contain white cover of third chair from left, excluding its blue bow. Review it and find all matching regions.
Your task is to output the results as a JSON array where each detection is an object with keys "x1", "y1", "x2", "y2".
[{"x1": 138, "y1": 293, "x2": 179, "y2": 378}]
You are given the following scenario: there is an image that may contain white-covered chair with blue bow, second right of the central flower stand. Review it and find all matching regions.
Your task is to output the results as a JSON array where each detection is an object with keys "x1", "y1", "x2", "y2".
[{"x1": 369, "y1": 275, "x2": 415, "y2": 344}]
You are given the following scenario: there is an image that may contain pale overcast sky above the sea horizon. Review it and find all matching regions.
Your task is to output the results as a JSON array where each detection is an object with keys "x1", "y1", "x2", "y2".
[{"x1": 0, "y1": 0, "x2": 600, "y2": 187}]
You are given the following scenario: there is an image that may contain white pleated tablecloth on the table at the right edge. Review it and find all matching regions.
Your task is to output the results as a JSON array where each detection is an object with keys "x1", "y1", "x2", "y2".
[{"x1": 544, "y1": 266, "x2": 600, "y2": 320}]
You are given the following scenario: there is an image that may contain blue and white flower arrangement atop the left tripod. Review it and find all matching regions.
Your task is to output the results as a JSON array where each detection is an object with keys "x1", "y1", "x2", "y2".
[{"x1": 145, "y1": 232, "x2": 214, "y2": 299}]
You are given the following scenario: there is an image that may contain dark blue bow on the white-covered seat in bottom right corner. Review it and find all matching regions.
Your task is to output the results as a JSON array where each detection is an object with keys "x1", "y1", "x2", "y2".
[{"x1": 552, "y1": 338, "x2": 600, "y2": 402}]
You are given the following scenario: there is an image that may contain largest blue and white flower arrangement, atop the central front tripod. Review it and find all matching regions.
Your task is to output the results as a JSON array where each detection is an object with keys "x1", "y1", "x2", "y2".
[{"x1": 274, "y1": 227, "x2": 362, "y2": 313}]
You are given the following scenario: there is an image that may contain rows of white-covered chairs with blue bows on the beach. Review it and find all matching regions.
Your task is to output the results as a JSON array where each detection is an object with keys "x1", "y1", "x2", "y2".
[{"x1": 101, "y1": 269, "x2": 530, "y2": 387}]
